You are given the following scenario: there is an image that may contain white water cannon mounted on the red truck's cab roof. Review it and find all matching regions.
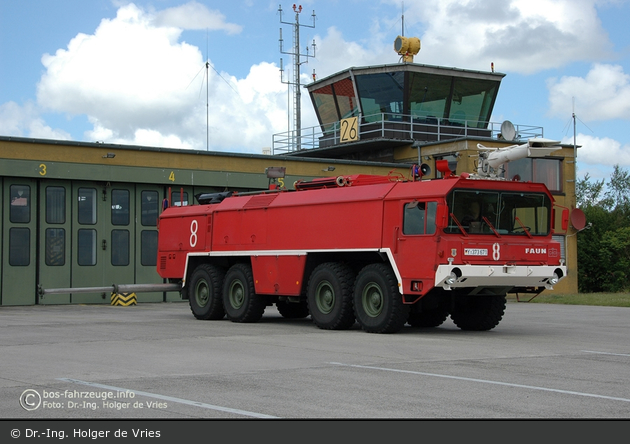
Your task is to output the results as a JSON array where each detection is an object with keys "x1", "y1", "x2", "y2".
[{"x1": 477, "y1": 128, "x2": 562, "y2": 177}]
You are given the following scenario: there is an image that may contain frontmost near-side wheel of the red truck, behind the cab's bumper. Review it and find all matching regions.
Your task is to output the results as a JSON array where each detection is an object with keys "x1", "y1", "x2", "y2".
[{"x1": 354, "y1": 264, "x2": 409, "y2": 333}]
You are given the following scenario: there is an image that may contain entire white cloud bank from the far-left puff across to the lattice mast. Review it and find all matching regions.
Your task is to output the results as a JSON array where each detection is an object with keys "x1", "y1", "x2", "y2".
[{"x1": 37, "y1": 4, "x2": 286, "y2": 153}]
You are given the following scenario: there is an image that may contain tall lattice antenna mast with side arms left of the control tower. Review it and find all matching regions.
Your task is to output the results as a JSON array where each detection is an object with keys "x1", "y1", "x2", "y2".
[{"x1": 278, "y1": 4, "x2": 316, "y2": 151}]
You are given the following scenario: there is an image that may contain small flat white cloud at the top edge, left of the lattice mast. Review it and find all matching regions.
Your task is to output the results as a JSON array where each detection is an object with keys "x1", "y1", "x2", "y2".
[{"x1": 155, "y1": 1, "x2": 243, "y2": 34}]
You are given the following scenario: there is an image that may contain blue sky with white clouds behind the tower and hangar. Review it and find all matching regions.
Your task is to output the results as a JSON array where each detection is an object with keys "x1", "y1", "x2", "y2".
[{"x1": 0, "y1": 0, "x2": 630, "y2": 179}]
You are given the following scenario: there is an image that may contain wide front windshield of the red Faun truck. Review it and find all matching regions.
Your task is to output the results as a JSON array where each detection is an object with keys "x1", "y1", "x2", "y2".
[{"x1": 445, "y1": 190, "x2": 552, "y2": 236}]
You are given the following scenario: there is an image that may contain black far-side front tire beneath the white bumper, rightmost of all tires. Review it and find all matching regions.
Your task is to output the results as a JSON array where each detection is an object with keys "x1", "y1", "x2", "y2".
[{"x1": 451, "y1": 295, "x2": 505, "y2": 331}]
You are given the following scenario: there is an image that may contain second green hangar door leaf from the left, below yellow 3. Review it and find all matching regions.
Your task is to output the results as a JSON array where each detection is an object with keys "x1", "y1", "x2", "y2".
[{"x1": 38, "y1": 180, "x2": 72, "y2": 304}]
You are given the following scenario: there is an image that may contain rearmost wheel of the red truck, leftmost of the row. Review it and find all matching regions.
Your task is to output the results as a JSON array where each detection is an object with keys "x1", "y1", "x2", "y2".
[{"x1": 187, "y1": 264, "x2": 225, "y2": 320}]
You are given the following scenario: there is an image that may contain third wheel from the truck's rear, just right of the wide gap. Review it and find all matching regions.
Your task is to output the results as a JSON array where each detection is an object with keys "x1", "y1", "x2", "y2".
[{"x1": 306, "y1": 262, "x2": 355, "y2": 330}]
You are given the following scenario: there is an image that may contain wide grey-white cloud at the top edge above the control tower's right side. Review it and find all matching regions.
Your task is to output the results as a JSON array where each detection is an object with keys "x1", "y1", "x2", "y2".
[{"x1": 382, "y1": 0, "x2": 611, "y2": 74}]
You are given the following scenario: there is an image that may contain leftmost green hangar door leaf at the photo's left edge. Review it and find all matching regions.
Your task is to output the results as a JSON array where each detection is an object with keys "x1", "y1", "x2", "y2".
[{"x1": 0, "y1": 178, "x2": 37, "y2": 305}]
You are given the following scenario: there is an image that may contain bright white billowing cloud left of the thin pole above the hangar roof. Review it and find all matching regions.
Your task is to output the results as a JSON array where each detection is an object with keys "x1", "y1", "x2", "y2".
[{"x1": 37, "y1": 4, "x2": 202, "y2": 135}]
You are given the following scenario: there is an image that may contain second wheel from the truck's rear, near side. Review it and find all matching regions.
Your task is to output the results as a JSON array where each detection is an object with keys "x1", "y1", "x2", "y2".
[{"x1": 223, "y1": 264, "x2": 267, "y2": 322}]
